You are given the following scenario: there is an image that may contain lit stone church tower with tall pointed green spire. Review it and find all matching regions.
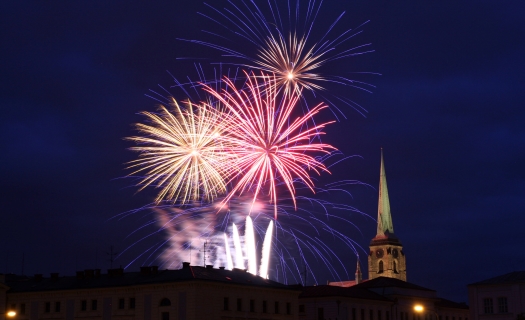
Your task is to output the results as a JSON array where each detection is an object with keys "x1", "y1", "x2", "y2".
[{"x1": 368, "y1": 149, "x2": 407, "y2": 281}]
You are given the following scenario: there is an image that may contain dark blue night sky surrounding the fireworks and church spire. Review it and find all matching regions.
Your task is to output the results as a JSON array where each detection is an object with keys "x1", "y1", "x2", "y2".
[{"x1": 0, "y1": 0, "x2": 525, "y2": 301}]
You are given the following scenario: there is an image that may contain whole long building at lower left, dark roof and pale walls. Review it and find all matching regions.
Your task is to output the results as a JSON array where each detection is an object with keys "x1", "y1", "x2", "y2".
[{"x1": 3, "y1": 263, "x2": 301, "y2": 320}]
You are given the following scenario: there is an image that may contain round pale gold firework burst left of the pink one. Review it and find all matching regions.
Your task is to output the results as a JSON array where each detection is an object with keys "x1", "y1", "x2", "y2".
[{"x1": 127, "y1": 100, "x2": 235, "y2": 203}]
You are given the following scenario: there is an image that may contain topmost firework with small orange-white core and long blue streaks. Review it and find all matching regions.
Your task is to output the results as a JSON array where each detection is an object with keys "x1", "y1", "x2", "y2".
[{"x1": 180, "y1": 0, "x2": 374, "y2": 108}]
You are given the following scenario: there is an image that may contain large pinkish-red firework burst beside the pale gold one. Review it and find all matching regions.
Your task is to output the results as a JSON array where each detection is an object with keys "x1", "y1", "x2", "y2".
[{"x1": 204, "y1": 73, "x2": 335, "y2": 218}]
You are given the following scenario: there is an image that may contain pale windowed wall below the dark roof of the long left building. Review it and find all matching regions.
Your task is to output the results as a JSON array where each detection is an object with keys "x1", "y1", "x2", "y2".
[{"x1": 6, "y1": 281, "x2": 300, "y2": 320}]
